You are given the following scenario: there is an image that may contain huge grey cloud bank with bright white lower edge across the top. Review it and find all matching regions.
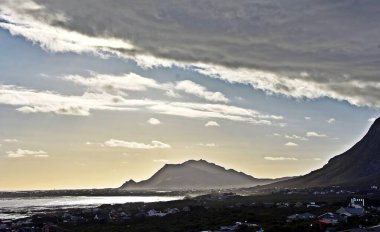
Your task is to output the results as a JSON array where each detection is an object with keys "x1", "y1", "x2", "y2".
[{"x1": 0, "y1": 0, "x2": 380, "y2": 107}]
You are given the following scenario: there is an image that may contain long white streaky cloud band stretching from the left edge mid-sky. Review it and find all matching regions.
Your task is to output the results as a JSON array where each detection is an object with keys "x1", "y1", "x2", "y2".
[{"x1": 0, "y1": 85, "x2": 283, "y2": 125}]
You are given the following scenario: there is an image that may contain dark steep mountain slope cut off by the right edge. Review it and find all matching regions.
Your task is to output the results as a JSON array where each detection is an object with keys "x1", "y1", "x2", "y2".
[{"x1": 265, "y1": 118, "x2": 380, "y2": 188}]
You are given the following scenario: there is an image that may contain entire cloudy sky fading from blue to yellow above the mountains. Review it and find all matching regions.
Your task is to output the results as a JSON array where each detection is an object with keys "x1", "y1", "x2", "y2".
[{"x1": 0, "y1": 0, "x2": 380, "y2": 190}]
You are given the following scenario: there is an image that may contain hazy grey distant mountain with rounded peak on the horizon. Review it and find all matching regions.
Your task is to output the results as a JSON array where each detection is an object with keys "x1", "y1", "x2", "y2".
[{"x1": 120, "y1": 160, "x2": 288, "y2": 190}]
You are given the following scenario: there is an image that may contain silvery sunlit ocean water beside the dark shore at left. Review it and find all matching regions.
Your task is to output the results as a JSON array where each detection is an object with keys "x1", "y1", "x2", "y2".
[{"x1": 0, "y1": 196, "x2": 183, "y2": 220}]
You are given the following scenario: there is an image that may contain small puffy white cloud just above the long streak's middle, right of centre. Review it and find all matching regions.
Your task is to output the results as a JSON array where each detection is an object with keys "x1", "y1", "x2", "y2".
[{"x1": 175, "y1": 80, "x2": 229, "y2": 103}]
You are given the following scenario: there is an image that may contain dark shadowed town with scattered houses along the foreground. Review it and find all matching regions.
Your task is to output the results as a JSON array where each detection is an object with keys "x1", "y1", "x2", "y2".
[{"x1": 0, "y1": 186, "x2": 380, "y2": 232}]
